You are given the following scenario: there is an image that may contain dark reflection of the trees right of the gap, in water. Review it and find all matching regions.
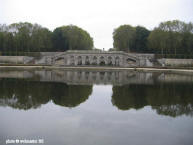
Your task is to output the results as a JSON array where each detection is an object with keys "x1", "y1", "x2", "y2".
[{"x1": 112, "y1": 83, "x2": 193, "y2": 117}]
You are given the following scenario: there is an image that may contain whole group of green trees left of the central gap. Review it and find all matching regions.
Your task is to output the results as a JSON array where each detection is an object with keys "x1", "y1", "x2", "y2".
[{"x1": 0, "y1": 22, "x2": 93, "y2": 53}]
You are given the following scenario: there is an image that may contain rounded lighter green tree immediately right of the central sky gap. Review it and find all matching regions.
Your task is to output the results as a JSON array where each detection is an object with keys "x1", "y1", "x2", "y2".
[{"x1": 113, "y1": 25, "x2": 136, "y2": 52}]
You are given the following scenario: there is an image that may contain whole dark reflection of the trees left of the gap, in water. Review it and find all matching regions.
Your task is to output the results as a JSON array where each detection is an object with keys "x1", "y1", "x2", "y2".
[{"x1": 0, "y1": 79, "x2": 92, "y2": 110}]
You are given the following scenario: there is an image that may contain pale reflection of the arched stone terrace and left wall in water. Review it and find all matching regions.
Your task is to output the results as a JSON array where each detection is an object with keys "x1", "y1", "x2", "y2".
[{"x1": 0, "y1": 70, "x2": 153, "y2": 85}]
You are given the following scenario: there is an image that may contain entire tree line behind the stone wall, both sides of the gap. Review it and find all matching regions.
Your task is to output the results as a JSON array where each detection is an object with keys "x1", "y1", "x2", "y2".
[{"x1": 0, "y1": 20, "x2": 193, "y2": 57}]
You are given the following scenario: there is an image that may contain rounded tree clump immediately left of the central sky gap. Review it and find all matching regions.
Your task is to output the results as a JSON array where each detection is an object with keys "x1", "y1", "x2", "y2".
[{"x1": 52, "y1": 25, "x2": 93, "y2": 51}]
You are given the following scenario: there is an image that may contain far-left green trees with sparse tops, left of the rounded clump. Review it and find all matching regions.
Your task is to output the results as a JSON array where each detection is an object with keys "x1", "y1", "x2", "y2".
[{"x1": 0, "y1": 22, "x2": 52, "y2": 52}]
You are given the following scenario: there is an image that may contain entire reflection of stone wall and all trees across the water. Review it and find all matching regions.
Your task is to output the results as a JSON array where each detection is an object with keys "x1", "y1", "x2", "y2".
[{"x1": 0, "y1": 70, "x2": 193, "y2": 117}]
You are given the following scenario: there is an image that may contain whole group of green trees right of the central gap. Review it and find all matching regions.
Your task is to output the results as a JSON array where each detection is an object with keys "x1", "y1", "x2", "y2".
[{"x1": 113, "y1": 20, "x2": 193, "y2": 57}]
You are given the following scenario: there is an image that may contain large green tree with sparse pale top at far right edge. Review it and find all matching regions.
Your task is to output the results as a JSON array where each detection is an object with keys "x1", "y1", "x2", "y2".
[{"x1": 148, "y1": 20, "x2": 193, "y2": 56}]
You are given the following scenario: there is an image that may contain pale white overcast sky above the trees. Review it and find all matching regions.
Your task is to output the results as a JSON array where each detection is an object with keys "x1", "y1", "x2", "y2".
[{"x1": 0, "y1": 0, "x2": 193, "y2": 50}]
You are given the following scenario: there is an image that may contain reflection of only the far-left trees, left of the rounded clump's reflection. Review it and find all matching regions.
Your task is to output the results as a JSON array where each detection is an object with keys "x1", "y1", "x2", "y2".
[{"x1": 0, "y1": 79, "x2": 49, "y2": 110}]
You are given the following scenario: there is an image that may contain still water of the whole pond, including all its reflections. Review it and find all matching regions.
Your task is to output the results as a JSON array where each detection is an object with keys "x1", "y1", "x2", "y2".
[{"x1": 0, "y1": 70, "x2": 193, "y2": 145}]
